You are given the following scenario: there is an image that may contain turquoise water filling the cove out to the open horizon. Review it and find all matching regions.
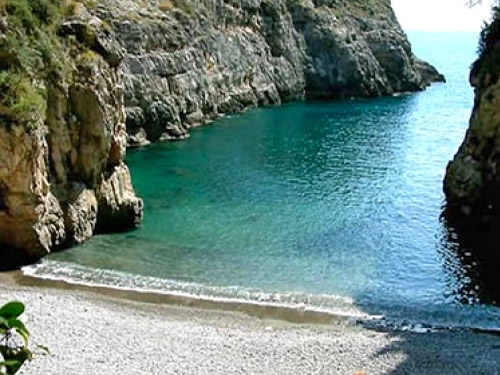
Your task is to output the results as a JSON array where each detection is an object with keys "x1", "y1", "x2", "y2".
[{"x1": 26, "y1": 33, "x2": 500, "y2": 329}]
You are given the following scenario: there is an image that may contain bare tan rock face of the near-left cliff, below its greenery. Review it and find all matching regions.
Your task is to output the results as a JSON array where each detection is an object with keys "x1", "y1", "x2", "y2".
[{"x1": 0, "y1": 15, "x2": 142, "y2": 265}]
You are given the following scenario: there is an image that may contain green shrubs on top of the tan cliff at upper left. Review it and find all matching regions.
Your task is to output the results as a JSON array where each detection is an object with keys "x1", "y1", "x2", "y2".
[{"x1": 0, "y1": 0, "x2": 65, "y2": 126}]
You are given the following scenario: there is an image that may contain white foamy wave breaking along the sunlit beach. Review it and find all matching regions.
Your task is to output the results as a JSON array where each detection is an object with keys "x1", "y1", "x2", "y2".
[{"x1": 22, "y1": 260, "x2": 377, "y2": 320}]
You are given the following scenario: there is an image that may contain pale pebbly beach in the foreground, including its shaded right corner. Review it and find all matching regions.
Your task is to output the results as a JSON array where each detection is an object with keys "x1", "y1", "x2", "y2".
[{"x1": 0, "y1": 273, "x2": 500, "y2": 375}]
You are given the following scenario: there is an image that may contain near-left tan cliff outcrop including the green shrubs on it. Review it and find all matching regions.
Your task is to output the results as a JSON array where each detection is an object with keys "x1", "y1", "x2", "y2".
[{"x1": 0, "y1": 0, "x2": 142, "y2": 266}]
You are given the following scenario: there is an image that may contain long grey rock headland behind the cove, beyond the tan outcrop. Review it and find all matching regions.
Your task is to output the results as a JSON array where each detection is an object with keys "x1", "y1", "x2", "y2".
[{"x1": 88, "y1": 0, "x2": 444, "y2": 145}]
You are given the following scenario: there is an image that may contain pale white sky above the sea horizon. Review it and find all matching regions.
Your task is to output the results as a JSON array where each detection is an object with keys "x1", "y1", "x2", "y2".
[{"x1": 392, "y1": 0, "x2": 494, "y2": 31}]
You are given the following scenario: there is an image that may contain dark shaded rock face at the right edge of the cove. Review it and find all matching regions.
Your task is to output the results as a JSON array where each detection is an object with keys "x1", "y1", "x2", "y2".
[{"x1": 444, "y1": 20, "x2": 500, "y2": 223}]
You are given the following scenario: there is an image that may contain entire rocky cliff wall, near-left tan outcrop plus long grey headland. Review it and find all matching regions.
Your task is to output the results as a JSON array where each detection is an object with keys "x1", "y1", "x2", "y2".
[{"x1": 0, "y1": 0, "x2": 444, "y2": 266}]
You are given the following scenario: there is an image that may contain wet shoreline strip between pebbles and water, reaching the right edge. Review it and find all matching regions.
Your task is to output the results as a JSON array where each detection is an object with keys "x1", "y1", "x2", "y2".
[{"x1": 12, "y1": 267, "x2": 500, "y2": 337}]
